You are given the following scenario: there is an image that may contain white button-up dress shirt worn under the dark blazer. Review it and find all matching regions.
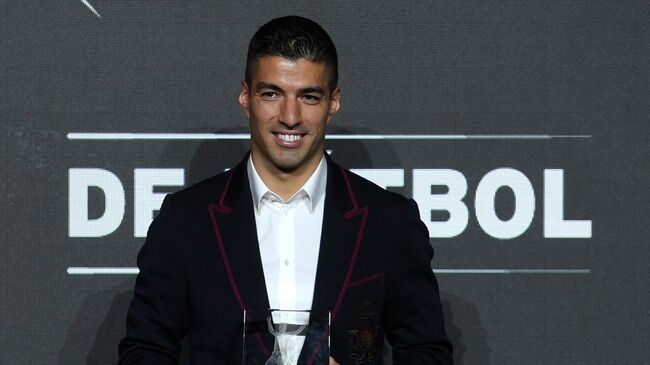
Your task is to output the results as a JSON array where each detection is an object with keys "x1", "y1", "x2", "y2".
[{"x1": 247, "y1": 156, "x2": 327, "y2": 364}]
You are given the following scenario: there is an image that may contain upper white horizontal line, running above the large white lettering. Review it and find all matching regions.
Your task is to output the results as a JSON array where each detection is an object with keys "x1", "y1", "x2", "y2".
[{"x1": 67, "y1": 132, "x2": 591, "y2": 141}]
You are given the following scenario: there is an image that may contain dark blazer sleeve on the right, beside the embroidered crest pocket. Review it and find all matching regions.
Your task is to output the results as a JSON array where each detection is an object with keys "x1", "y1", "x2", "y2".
[{"x1": 384, "y1": 199, "x2": 453, "y2": 365}]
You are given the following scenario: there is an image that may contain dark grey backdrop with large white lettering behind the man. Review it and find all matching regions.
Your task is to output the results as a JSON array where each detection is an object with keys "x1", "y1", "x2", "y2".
[{"x1": 0, "y1": 0, "x2": 650, "y2": 364}]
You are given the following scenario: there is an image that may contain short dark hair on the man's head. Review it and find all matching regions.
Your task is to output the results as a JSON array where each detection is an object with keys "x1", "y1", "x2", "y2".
[{"x1": 245, "y1": 16, "x2": 339, "y2": 92}]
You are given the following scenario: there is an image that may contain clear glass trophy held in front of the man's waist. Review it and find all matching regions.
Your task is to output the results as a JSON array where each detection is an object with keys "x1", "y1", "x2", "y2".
[{"x1": 242, "y1": 309, "x2": 331, "y2": 365}]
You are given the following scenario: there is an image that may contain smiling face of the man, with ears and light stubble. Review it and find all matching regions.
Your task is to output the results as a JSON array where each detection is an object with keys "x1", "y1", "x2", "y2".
[{"x1": 239, "y1": 56, "x2": 340, "y2": 175}]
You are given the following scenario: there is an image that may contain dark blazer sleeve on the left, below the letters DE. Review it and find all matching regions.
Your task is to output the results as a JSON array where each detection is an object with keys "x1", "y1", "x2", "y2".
[{"x1": 118, "y1": 195, "x2": 188, "y2": 365}]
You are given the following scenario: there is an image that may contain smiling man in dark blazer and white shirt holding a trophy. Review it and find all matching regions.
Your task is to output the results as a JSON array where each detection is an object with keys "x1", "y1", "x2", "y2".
[{"x1": 119, "y1": 17, "x2": 452, "y2": 365}]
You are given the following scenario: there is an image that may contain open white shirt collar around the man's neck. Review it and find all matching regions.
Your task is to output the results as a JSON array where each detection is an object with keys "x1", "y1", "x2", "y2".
[{"x1": 246, "y1": 155, "x2": 327, "y2": 214}]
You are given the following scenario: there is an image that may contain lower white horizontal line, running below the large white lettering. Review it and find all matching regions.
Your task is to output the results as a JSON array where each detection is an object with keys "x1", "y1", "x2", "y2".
[{"x1": 66, "y1": 267, "x2": 591, "y2": 275}]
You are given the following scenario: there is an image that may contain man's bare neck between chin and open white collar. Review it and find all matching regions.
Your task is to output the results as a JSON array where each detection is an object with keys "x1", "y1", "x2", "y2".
[{"x1": 251, "y1": 153, "x2": 323, "y2": 201}]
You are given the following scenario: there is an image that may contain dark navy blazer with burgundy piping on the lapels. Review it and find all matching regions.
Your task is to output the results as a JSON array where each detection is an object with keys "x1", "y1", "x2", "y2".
[{"x1": 119, "y1": 156, "x2": 452, "y2": 365}]
